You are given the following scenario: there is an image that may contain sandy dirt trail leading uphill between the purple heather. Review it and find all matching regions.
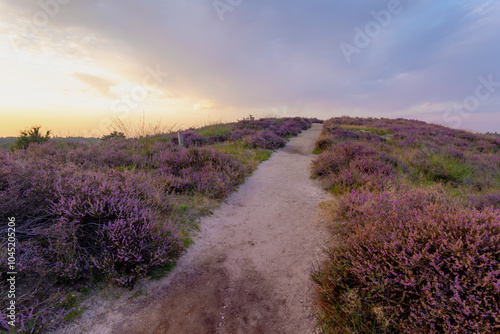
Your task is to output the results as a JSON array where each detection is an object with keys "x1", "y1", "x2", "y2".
[{"x1": 58, "y1": 124, "x2": 327, "y2": 334}]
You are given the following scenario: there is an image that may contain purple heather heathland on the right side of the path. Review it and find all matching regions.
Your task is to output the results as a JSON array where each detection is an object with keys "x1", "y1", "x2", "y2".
[{"x1": 312, "y1": 117, "x2": 500, "y2": 333}]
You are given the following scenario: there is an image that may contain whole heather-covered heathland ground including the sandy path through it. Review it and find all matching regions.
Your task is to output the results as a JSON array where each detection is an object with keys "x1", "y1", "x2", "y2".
[{"x1": 0, "y1": 117, "x2": 500, "y2": 333}]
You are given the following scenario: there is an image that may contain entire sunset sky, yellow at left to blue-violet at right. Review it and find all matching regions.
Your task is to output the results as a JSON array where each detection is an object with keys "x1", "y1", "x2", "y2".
[{"x1": 0, "y1": 0, "x2": 500, "y2": 136}]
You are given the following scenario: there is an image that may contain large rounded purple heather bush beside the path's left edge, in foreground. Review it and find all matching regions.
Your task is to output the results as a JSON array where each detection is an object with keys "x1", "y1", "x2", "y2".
[{"x1": 47, "y1": 172, "x2": 180, "y2": 285}]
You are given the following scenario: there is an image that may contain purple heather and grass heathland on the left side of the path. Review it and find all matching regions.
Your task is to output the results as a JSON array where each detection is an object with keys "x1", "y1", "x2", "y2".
[{"x1": 0, "y1": 118, "x2": 317, "y2": 333}]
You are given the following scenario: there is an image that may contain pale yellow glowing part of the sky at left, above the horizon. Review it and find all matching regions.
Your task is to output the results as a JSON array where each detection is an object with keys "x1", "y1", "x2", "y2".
[{"x1": 0, "y1": 3, "x2": 248, "y2": 136}]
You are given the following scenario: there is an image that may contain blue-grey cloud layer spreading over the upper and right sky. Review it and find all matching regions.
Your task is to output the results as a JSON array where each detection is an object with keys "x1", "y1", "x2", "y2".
[{"x1": 2, "y1": 0, "x2": 500, "y2": 130}]
